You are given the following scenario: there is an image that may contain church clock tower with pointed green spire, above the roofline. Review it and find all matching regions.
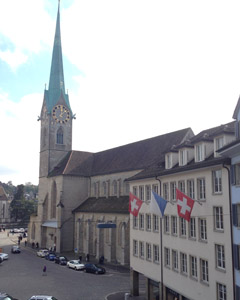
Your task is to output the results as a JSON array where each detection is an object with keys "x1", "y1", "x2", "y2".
[{"x1": 39, "y1": 1, "x2": 72, "y2": 178}]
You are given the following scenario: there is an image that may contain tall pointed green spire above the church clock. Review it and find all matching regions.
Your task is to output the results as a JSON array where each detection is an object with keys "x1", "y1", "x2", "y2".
[{"x1": 45, "y1": 1, "x2": 70, "y2": 111}]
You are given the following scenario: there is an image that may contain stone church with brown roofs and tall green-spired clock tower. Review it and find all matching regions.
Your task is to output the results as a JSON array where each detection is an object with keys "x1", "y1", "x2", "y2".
[{"x1": 28, "y1": 2, "x2": 194, "y2": 265}]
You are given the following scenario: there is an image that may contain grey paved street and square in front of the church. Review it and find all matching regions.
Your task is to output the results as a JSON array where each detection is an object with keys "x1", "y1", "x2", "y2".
[{"x1": 0, "y1": 232, "x2": 130, "y2": 300}]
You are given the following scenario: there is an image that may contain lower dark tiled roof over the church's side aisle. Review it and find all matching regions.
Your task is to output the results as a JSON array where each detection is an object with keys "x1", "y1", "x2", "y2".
[{"x1": 73, "y1": 196, "x2": 129, "y2": 214}]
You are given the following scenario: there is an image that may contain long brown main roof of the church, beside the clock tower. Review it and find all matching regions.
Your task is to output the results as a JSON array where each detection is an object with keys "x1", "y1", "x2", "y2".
[{"x1": 49, "y1": 128, "x2": 193, "y2": 176}]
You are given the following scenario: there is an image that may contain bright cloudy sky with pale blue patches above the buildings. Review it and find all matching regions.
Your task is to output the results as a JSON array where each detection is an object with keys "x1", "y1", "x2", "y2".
[{"x1": 0, "y1": 0, "x2": 240, "y2": 185}]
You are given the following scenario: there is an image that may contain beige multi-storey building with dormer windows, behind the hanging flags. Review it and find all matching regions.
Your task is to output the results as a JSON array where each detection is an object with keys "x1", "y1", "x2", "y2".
[{"x1": 129, "y1": 123, "x2": 234, "y2": 300}]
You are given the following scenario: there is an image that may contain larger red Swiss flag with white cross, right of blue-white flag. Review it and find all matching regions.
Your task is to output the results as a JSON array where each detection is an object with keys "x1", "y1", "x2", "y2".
[{"x1": 176, "y1": 189, "x2": 194, "y2": 222}]
